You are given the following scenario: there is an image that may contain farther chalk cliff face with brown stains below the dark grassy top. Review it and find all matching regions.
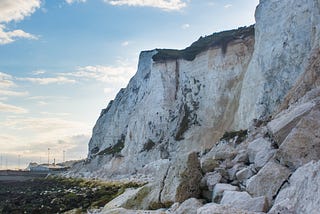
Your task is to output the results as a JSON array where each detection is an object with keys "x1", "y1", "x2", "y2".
[{"x1": 84, "y1": 35, "x2": 254, "y2": 179}]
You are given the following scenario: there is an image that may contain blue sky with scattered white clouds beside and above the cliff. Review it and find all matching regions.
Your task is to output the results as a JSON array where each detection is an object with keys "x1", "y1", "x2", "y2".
[{"x1": 0, "y1": 0, "x2": 258, "y2": 169}]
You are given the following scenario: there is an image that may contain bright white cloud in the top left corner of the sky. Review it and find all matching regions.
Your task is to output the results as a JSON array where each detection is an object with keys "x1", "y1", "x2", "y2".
[{"x1": 0, "y1": 0, "x2": 41, "y2": 45}]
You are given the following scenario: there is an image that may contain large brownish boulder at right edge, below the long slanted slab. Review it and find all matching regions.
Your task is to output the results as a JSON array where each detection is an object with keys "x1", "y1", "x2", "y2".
[{"x1": 276, "y1": 107, "x2": 320, "y2": 170}]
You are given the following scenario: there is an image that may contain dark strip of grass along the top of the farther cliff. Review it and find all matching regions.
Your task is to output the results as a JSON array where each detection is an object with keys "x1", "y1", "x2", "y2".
[{"x1": 152, "y1": 25, "x2": 254, "y2": 62}]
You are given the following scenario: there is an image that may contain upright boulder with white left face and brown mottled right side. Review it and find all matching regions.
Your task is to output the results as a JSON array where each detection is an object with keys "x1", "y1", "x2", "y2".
[{"x1": 160, "y1": 152, "x2": 202, "y2": 207}]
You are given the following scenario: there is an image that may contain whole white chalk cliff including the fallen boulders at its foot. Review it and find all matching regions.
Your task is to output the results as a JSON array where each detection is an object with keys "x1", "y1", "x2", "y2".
[{"x1": 70, "y1": 0, "x2": 320, "y2": 213}]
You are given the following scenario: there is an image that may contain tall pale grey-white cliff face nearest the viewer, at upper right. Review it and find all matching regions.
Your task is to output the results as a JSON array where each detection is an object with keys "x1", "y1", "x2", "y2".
[{"x1": 236, "y1": 0, "x2": 319, "y2": 128}]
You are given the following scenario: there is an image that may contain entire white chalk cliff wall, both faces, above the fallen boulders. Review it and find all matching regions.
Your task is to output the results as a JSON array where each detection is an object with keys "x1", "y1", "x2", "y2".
[{"x1": 74, "y1": 0, "x2": 320, "y2": 185}]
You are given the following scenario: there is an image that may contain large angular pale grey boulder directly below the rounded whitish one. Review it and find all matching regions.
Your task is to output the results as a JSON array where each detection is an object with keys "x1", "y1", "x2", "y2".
[{"x1": 246, "y1": 161, "x2": 290, "y2": 204}]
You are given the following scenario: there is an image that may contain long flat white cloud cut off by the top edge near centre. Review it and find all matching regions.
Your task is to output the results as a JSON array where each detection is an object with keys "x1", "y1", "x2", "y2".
[{"x1": 104, "y1": 0, "x2": 187, "y2": 11}]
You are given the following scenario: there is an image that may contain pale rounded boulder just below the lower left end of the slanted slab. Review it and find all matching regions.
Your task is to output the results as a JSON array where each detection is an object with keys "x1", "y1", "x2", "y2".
[{"x1": 248, "y1": 138, "x2": 275, "y2": 170}]
